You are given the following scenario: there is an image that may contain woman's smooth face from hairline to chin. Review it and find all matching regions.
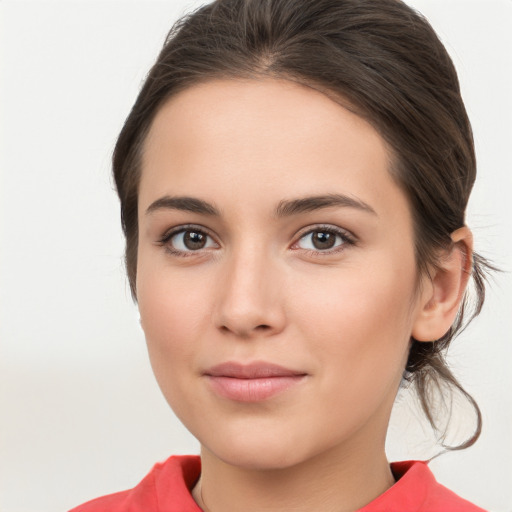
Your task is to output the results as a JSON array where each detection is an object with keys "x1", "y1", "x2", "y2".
[{"x1": 136, "y1": 79, "x2": 428, "y2": 468}]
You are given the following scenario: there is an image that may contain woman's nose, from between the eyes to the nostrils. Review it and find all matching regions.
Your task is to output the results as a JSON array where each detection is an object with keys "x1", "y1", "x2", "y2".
[{"x1": 210, "y1": 246, "x2": 286, "y2": 339}]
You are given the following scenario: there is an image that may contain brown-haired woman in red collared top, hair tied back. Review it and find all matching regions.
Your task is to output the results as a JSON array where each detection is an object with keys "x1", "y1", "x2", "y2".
[{"x1": 71, "y1": 0, "x2": 488, "y2": 512}]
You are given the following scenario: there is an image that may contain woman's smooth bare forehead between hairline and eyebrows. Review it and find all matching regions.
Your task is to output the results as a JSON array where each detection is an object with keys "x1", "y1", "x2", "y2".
[{"x1": 140, "y1": 79, "x2": 403, "y2": 220}]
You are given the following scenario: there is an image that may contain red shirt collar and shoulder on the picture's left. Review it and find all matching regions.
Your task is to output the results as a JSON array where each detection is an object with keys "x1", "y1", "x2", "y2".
[{"x1": 69, "y1": 455, "x2": 201, "y2": 512}]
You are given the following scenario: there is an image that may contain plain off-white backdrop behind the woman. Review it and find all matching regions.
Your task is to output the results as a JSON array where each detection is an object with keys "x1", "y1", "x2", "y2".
[{"x1": 0, "y1": 0, "x2": 512, "y2": 512}]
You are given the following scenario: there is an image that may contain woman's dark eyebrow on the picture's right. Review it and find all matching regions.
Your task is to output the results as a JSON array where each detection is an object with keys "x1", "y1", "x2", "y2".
[{"x1": 275, "y1": 194, "x2": 378, "y2": 217}]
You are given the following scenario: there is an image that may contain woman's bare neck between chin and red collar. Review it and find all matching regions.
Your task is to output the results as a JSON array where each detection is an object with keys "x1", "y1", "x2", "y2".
[{"x1": 193, "y1": 436, "x2": 394, "y2": 512}]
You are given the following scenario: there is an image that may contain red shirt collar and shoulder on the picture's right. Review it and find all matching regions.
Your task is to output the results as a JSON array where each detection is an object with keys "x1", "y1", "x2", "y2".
[{"x1": 360, "y1": 461, "x2": 485, "y2": 512}]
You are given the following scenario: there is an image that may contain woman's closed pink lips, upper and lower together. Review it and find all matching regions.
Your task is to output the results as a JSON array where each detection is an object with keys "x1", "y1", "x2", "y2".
[{"x1": 204, "y1": 362, "x2": 307, "y2": 402}]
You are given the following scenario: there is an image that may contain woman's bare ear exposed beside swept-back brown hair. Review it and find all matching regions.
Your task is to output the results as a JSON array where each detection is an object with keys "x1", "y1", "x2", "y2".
[{"x1": 411, "y1": 226, "x2": 473, "y2": 341}]
